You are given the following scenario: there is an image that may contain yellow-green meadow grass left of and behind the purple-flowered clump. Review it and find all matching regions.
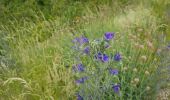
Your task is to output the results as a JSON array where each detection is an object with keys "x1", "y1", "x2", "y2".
[{"x1": 0, "y1": 0, "x2": 169, "y2": 100}]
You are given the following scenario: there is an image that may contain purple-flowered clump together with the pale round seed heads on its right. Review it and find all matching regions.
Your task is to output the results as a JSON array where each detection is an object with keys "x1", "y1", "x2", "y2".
[{"x1": 72, "y1": 32, "x2": 157, "y2": 100}]
